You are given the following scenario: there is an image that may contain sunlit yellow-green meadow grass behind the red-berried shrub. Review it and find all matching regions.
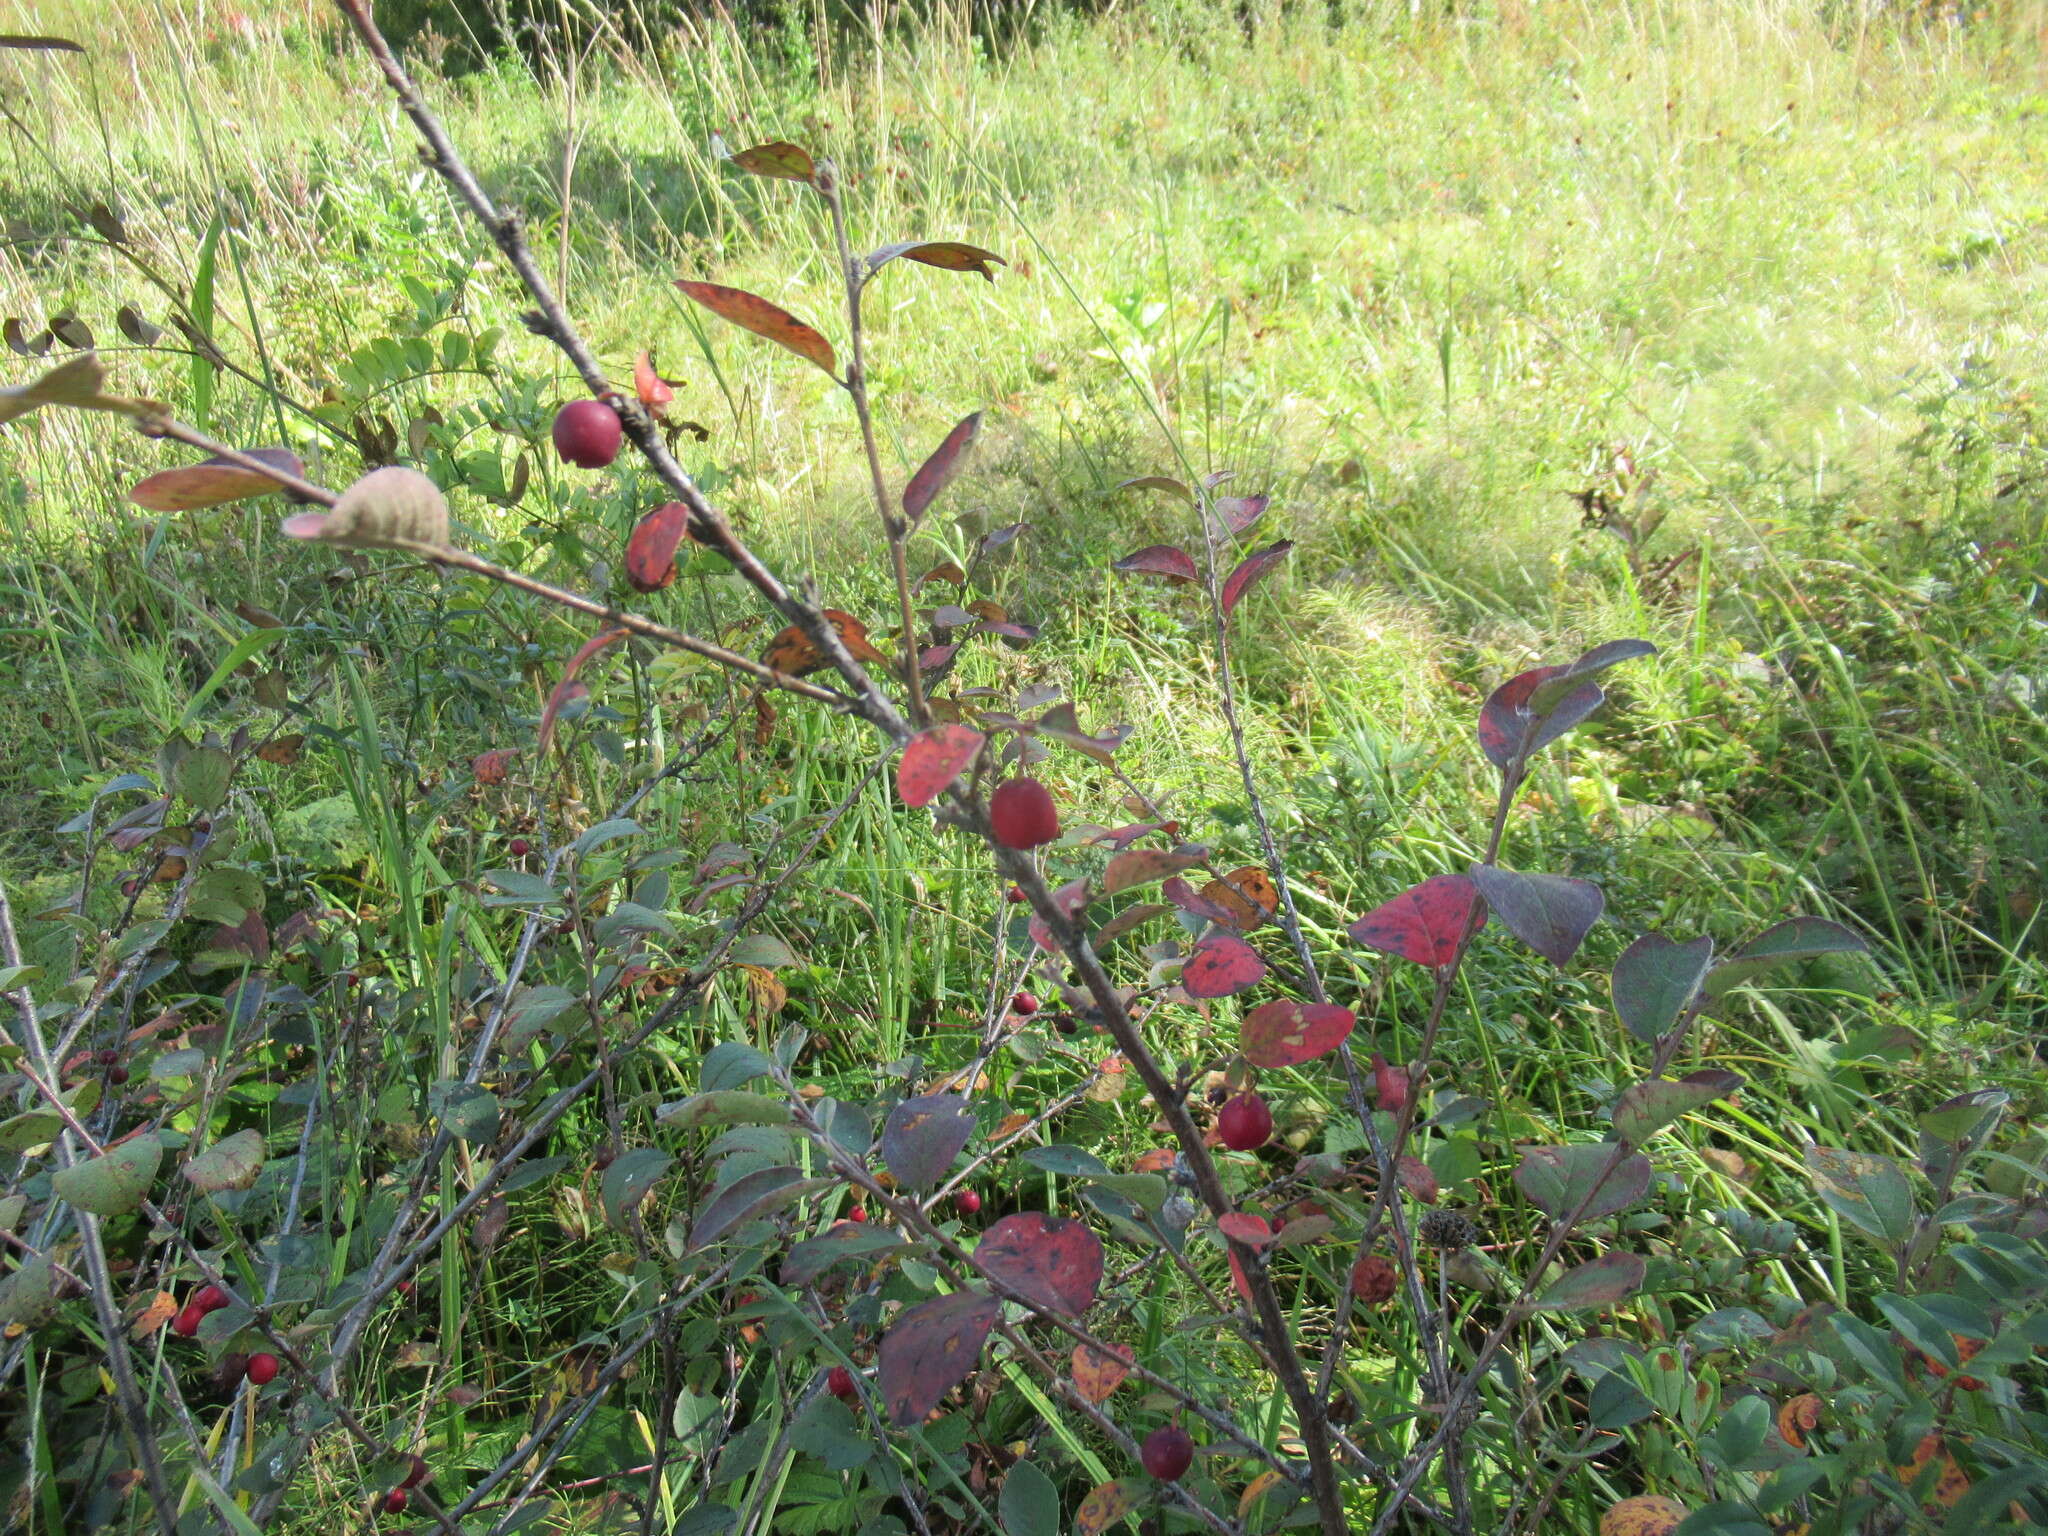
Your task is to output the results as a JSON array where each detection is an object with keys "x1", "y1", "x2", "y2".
[{"x1": 0, "y1": 0, "x2": 2048, "y2": 1536}]
